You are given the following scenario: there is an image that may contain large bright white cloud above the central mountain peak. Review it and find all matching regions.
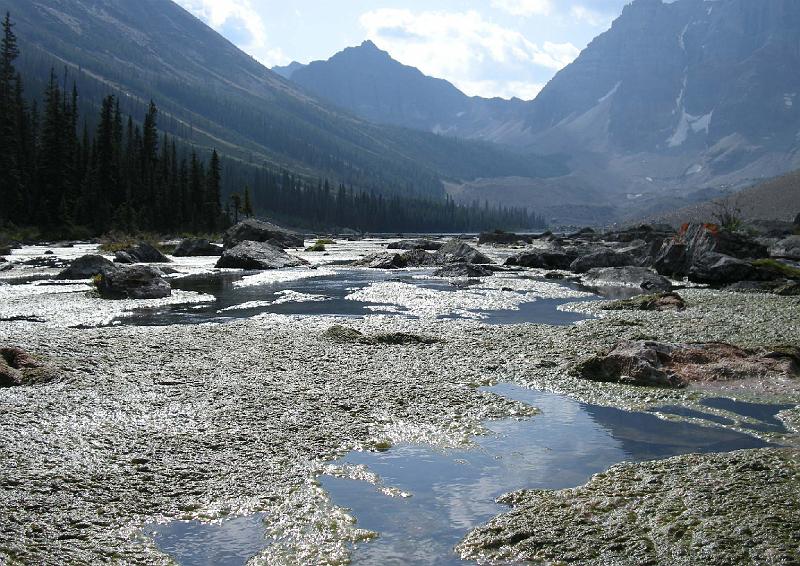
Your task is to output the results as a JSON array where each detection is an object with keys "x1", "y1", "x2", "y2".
[{"x1": 360, "y1": 8, "x2": 579, "y2": 98}]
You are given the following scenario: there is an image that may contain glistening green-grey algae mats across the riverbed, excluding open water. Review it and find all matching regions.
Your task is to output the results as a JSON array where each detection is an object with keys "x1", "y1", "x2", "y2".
[{"x1": 0, "y1": 230, "x2": 800, "y2": 564}]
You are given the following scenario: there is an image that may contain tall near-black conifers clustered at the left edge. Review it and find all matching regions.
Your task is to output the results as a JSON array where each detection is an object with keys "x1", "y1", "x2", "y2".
[{"x1": 0, "y1": 14, "x2": 227, "y2": 234}]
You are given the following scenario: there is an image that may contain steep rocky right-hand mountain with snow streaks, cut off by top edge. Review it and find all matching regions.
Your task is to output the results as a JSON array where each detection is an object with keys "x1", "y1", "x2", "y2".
[{"x1": 526, "y1": 0, "x2": 800, "y2": 195}]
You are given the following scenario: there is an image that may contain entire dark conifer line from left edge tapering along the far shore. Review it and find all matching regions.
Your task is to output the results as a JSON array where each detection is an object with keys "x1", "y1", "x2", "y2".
[{"x1": 0, "y1": 14, "x2": 544, "y2": 237}]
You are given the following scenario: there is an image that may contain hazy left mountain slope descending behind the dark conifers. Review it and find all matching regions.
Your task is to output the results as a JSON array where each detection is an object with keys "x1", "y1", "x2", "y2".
[{"x1": 0, "y1": 0, "x2": 564, "y2": 206}]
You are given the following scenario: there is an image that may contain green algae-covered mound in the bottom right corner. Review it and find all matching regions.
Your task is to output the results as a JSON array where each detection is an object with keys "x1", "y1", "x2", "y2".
[{"x1": 457, "y1": 449, "x2": 800, "y2": 566}]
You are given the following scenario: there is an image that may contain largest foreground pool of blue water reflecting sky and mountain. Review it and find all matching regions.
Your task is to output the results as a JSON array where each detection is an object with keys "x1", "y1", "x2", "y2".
[{"x1": 321, "y1": 385, "x2": 766, "y2": 565}]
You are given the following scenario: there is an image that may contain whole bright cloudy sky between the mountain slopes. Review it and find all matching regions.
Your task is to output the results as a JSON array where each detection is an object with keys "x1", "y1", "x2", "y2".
[{"x1": 176, "y1": 0, "x2": 629, "y2": 100}]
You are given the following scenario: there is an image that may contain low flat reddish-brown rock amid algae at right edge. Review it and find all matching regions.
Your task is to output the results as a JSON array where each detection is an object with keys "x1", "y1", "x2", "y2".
[{"x1": 574, "y1": 340, "x2": 800, "y2": 388}]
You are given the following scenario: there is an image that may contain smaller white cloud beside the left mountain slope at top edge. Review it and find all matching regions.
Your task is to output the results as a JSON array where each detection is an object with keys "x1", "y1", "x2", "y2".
[{"x1": 176, "y1": 0, "x2": 290, "y2": 67}]
